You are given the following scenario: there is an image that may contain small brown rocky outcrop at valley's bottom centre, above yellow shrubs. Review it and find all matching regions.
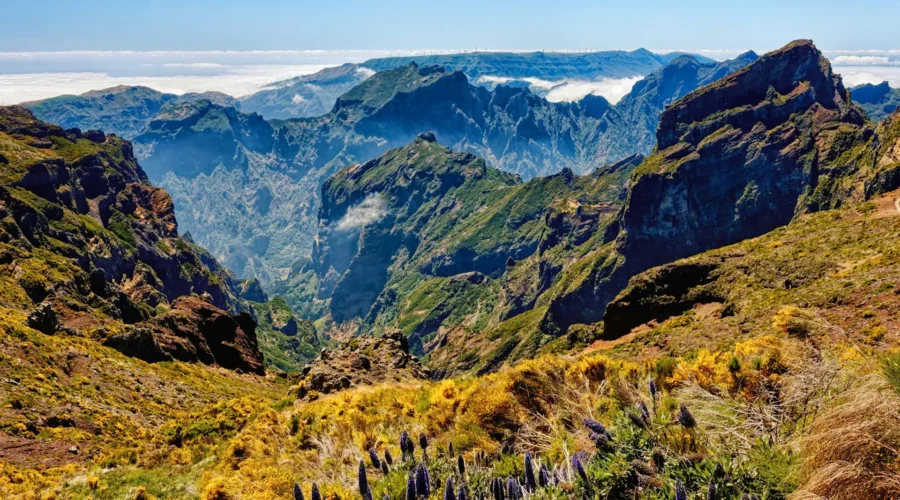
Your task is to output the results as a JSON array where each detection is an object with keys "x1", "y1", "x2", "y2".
[{"x1": 292, "y1": 332, "x2": 428, "y2": 398}]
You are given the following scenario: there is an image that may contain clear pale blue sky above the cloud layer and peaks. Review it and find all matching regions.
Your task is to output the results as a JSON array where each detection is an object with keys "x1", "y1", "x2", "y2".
[{"x1": 0, "y1": 0, "x2": 900, "y2": 52}]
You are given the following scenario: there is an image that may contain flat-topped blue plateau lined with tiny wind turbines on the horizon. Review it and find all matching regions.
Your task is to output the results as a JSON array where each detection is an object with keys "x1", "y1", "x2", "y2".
[{"x1": 360, "y1": 49, "x2": 715, "y2": 82}]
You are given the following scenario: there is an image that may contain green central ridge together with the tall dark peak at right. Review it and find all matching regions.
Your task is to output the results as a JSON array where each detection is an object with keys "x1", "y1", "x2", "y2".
[{"x1": 291, "y1": 41, "x2": 900, "y2": 376}]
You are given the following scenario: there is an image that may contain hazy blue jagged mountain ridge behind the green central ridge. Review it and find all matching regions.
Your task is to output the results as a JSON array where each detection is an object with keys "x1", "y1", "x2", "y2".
[{"x1": 26, "y1": 53, "x2": 756, "y2": 298}]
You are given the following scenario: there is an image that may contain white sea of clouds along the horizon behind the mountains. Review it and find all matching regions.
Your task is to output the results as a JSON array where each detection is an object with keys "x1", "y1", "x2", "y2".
[{"x1": 0, "y1": 49, "x2": 900, "y2": 105}]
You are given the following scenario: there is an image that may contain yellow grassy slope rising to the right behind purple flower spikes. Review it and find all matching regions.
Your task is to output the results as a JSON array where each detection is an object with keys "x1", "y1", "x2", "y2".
[{"x1": 12, "y1": 198, "x2": 900, "y2": 498}]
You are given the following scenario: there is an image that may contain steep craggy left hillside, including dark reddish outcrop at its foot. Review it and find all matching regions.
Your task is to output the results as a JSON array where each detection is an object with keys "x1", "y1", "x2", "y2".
[{"x1": 0, "y1": 107, "x2": 262, "y2": 373}]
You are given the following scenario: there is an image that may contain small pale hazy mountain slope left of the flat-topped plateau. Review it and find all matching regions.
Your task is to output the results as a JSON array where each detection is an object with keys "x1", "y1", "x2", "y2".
[{"x1": 241, "y1": 64, "x2": 374, "y2": 119}]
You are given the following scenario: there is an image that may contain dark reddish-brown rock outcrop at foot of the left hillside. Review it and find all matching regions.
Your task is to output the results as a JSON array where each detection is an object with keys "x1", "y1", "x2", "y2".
[{"x1": 132, "y1": 297, "x2": 265, "y2": 374}]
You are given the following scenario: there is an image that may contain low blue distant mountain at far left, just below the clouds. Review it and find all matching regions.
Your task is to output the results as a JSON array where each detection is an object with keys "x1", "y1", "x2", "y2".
[{"x1": 23, "y1": 85, "x2": 240, "y2": 139}]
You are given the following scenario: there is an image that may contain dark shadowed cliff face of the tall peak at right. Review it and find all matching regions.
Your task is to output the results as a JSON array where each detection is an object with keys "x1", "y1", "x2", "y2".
[{"x1": 545, "y1": 41, "x2": 889, "y2": 336}]
